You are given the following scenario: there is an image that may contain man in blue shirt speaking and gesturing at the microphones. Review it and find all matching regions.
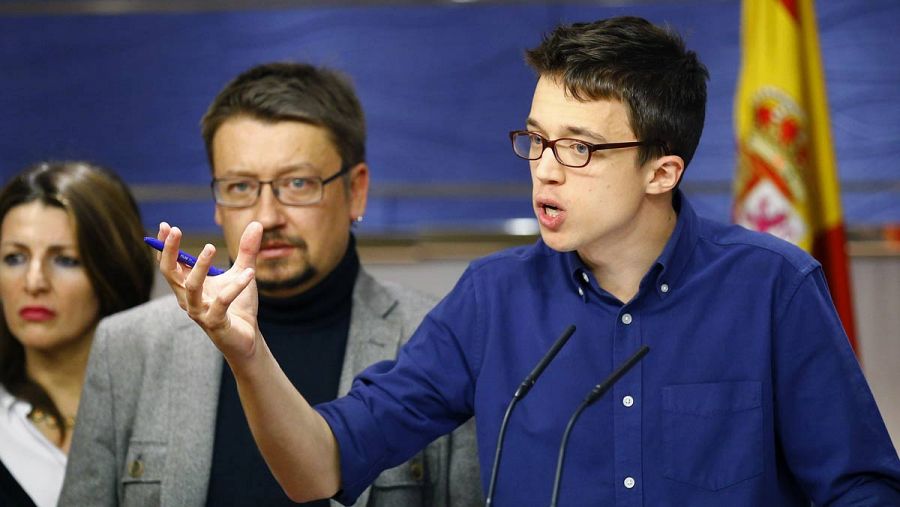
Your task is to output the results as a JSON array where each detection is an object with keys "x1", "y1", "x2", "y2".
[{"x1": 160, "y1": 13, "x2": 900, "y2": 507}]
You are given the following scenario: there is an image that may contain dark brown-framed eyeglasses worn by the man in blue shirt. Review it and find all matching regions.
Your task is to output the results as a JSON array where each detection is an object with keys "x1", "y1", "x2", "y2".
[{"x1": 509, "y1": 130, "x2": 661, "y2": 167}]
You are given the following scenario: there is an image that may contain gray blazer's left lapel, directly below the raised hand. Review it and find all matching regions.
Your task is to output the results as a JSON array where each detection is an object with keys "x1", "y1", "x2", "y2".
[{"x1": 160, "y1": 321, "x2": 224, "y2": 506}]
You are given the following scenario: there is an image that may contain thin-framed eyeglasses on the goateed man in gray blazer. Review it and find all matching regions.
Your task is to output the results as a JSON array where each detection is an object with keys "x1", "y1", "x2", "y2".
[{"x1": 211, "y1": 166, "x2": 350, "y2": 208}]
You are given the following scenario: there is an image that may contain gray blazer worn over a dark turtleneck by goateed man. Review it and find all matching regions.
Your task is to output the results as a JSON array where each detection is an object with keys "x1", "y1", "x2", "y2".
[{"x1": 59, "y1": 269, "x2": 484, "y2": 507}]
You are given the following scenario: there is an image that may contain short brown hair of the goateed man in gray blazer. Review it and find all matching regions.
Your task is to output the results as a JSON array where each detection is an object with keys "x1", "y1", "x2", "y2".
[{"x1": 200, "y1": 62, "x2": 366, "y2": 173}]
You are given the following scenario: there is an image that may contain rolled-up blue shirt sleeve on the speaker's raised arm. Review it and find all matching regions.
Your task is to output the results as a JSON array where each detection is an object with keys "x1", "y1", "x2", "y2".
[{"x1": 316, "y1": 271, "x2": 483, "y2": 504}]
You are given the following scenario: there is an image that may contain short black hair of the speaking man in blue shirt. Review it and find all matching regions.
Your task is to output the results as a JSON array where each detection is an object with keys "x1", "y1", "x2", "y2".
[{"x1": 526, "y1": 16, "x2": 709, "y2": 167}]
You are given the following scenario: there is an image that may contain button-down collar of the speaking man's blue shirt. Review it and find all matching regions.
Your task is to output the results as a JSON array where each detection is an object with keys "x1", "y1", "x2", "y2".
[{"x1": 563, "y1": 190, "x2": 699, "y2": 298}]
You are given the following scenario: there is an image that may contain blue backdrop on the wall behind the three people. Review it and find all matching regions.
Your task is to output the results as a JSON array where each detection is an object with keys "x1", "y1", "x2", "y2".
[{"x1": 0, "y1": 0, "x2": 900, "y2": 233}]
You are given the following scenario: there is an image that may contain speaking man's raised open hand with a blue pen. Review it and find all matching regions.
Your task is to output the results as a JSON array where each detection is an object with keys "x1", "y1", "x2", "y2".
[{"x1": 157, "y1": 222, "x2": 262, "y2": 366}]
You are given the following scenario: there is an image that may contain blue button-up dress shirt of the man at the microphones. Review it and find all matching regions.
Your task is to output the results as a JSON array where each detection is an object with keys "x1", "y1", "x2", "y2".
[{"x1": 317, "y1": 193, "x2": 900, "y2": 507}]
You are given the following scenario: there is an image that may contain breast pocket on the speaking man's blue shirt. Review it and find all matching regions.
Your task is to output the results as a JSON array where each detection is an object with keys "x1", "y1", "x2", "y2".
[{"x1": 662, "y1": 381, "x2": 763, "y2": 491}]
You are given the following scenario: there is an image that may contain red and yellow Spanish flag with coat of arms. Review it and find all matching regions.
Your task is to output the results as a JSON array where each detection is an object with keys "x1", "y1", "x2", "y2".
[{"x1": 732, "y1": 0, "x2": 856, "y2": 348}]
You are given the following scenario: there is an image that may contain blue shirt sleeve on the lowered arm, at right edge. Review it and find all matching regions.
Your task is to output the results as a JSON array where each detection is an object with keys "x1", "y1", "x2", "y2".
[{"x1": 773, "y1": 267, "x2": 900, "y2": 505}]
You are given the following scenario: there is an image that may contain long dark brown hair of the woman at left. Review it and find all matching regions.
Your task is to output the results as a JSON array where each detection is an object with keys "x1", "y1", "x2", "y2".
[{"x1": 0, "y1": 162, "x2": 156, "y2": 440}]
